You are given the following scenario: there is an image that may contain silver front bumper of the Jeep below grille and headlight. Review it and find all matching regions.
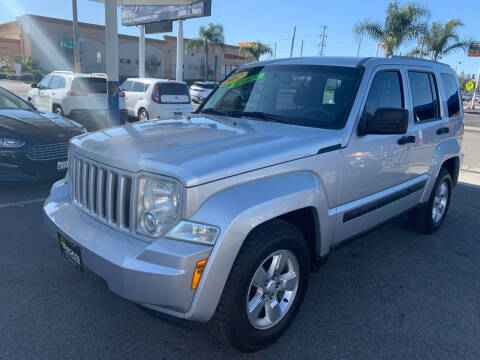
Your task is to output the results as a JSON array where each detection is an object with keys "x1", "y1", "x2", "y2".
[{"x1": 44, "y1": 180, "x2": 212, "y2": 318}]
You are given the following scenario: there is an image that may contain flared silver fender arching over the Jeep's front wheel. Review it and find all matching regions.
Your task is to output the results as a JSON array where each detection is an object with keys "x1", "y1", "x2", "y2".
[{"x1": 186, "y1": 172, "x2": 330, "y2": 321}]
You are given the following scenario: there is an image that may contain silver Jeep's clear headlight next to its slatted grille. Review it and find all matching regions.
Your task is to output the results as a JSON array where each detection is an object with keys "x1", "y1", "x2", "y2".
[{"x1": 137, "y1": 176, "x2": 181, "y2": 237}]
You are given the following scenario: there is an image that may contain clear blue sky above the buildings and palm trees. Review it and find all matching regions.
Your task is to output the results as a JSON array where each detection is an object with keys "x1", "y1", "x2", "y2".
[{"x1": 0, "y1": 0, "x2": 480, "y2": 74}]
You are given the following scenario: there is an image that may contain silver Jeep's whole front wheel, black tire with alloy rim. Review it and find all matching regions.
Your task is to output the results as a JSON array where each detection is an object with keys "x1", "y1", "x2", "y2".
[{"x1": 210, "y1": 220, "x2": 310, "y2": 352}]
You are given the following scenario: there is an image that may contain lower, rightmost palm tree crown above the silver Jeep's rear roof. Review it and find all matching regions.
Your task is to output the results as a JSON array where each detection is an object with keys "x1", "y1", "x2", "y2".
[{"x1": 408, "y1": 19, "x2": 473, "y2": 61}]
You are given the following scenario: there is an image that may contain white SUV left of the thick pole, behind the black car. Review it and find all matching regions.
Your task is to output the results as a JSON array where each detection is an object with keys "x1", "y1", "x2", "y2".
[{"x1": 28, "y1": 71, "x2": 126, "y2": 130}]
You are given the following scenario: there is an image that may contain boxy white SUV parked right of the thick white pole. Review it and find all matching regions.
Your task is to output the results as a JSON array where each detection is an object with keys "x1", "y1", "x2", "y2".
[{"x1": 120, "y1": 78, "x2": 193, "y2": 121}]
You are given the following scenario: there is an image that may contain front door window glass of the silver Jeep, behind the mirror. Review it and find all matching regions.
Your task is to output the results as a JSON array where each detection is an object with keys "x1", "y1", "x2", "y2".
[{"x1": 364, "y1": 71, "x2": 404, "y2": 119}]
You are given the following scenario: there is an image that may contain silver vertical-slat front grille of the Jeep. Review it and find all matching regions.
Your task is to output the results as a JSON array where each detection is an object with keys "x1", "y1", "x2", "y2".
[{"x1": 70, "y1": 155, "x2": 133, "y2": 230}]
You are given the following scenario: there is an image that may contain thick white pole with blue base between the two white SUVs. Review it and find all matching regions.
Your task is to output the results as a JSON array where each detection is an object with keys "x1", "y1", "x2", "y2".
[{"x1": 105, "y1": 0, "x2": 120, "y2": 125}]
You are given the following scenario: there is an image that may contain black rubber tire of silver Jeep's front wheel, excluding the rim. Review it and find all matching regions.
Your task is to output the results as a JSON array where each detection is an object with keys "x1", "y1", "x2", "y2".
[{"x1": 219, "y1": 224, "x2": 310, "y2": 351}]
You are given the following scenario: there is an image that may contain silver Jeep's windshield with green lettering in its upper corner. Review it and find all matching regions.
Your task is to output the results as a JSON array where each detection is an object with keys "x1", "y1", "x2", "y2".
[{"x1": 200, "y1": 65, "x2": 360, "y2": 129}]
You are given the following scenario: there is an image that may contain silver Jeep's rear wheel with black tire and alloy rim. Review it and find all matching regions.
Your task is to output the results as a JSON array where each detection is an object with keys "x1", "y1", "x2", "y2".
[{"x1": 408, "y1": 167, "x2": 453, "y2": 234}]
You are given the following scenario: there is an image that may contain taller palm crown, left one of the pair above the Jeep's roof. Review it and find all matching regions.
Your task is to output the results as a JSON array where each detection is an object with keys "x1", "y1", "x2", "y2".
[{"x1": 353, "y1": 1, "x2": 428, "y2": 57}]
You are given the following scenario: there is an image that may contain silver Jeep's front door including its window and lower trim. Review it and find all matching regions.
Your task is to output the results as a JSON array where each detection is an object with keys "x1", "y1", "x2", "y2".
[{"x1": 334, "y1": 67, "x2": 412, "y2": 242}]
